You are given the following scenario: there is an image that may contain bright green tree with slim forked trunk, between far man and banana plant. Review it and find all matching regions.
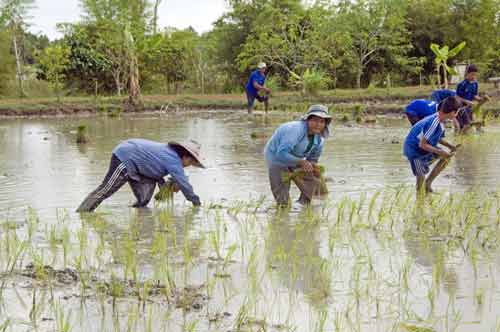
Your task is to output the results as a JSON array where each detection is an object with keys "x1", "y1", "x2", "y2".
[{"x1": 337, "y1": 0, "x2": 410, "y2": 88}]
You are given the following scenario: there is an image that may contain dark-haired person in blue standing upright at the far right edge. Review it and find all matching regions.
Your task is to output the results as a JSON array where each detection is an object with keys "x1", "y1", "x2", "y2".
[{"x1": 456, "y1": 64, "x2": 482, "y2": 133}]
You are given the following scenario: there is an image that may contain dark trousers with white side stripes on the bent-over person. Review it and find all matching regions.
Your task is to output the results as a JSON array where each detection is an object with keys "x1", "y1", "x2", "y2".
[{"x1": 76, "y1": 154, "x2": 156, "y2": 212}]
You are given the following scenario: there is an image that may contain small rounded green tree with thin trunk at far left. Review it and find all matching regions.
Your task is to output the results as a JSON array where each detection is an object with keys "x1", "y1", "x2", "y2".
[{"x1": 39, "y1": 44, "x2": 70, "y2": 102}]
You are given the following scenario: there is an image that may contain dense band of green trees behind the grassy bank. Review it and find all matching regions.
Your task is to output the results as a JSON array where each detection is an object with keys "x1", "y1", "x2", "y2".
[{"x1": 0, "y1": 0, "x2": 500, "y2": 95}]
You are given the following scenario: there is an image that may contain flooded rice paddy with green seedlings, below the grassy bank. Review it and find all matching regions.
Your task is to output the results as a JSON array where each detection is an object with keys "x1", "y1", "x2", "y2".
[{"x1": 0, "y1": 112, "x2": 500, "y2": 332}]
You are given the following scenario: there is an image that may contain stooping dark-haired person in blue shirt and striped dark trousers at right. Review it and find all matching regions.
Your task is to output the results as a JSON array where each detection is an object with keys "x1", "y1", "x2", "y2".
[{"x1": 403, "y1": 97, "x2": 462, "y2": 194}]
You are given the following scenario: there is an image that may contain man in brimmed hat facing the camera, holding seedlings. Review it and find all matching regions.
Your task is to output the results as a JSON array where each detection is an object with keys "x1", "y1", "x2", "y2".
[{"x1": 264, "y1": 105, "x2": 332, "y2": 206}]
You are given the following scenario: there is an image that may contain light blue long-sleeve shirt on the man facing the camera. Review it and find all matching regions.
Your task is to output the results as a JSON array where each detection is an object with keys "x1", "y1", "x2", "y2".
[{"x1": 264, "y1": 121, "x2": 324, "y2": 167}]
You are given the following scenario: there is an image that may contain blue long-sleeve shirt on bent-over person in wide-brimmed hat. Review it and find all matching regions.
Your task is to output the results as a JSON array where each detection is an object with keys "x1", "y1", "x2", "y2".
[{"x1": 113, "y1": 139, "x2": 200, "y2": 204}]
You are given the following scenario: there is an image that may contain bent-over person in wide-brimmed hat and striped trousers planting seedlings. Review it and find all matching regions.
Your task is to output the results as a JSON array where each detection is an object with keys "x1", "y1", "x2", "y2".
[{"x1": 76, "y1": 139, "x2": 204, "y2": 212}]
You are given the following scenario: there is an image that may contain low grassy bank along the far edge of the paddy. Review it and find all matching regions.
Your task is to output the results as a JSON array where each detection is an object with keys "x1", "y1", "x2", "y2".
[{"x1": 0, "y1": 84, "x2": 500, "y2": 116}]
